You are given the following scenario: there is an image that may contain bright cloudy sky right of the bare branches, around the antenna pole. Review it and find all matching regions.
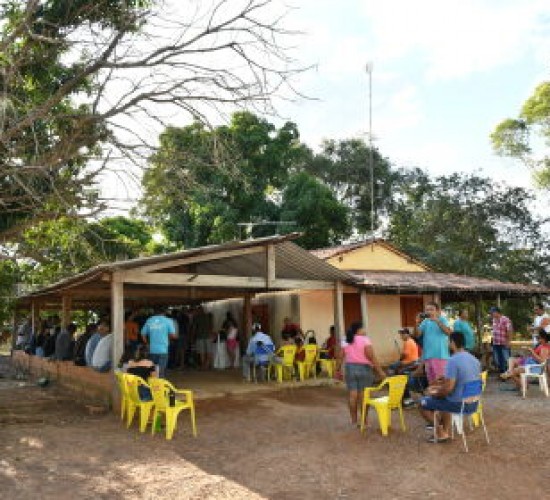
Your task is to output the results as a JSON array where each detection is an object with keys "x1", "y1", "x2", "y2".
[{"x1": 279, "y1": 0, "x2": 550, "y2": 186}]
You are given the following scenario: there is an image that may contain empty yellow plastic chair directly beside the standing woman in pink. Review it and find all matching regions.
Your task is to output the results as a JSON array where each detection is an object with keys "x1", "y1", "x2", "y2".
[{"x1": 361, "y1": 375, "x2": 407, "y2": 436}]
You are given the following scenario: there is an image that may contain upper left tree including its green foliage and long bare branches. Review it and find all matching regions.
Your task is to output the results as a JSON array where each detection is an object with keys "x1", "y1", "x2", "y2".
[{"x1": 0, "y1": 0, "x2": 306, "y2": 247}]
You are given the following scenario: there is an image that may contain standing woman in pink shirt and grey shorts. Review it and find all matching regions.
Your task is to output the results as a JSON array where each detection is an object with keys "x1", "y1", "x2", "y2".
[{"x1": 342, "y1": 322, "x2": 386, "y2": 426}]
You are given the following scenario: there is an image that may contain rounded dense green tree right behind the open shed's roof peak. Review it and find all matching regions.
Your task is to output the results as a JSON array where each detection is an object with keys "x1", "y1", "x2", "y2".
[{"x1": 281, "y1": 172, "x2": 350, "y2": 249}]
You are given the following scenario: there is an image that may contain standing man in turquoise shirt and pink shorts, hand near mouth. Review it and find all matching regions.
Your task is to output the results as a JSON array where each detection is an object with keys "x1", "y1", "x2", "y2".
[{"x1": 416, "y1": 302, "x2": 451, "y2": 383}]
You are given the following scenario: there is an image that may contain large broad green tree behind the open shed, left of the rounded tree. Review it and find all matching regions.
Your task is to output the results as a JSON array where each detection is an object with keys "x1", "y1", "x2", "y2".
[{"x1": 142, "y1": 112, "x2": 309, "y2": 247}]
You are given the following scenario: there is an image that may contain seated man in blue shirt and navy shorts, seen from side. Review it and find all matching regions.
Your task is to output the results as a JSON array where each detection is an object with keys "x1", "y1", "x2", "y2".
[{"x1": 420, "y1": 332, "x2": 481, "y2": 443}]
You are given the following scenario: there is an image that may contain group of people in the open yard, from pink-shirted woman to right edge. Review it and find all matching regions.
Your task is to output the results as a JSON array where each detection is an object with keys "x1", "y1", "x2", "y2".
[{"x1": 341, "y1": 302, "x2": 550, "y2": 443}]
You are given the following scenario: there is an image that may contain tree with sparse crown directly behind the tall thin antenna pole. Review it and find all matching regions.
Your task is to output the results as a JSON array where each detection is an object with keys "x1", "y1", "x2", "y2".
[{"x1": 305, "y1": 139, "x2": 397, "y2": 234}]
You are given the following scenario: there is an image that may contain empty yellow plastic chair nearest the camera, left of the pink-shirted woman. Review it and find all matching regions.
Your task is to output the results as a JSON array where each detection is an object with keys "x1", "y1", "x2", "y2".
[{"x1": 150, "y1": 378, "x2": 197, "y2": 439}]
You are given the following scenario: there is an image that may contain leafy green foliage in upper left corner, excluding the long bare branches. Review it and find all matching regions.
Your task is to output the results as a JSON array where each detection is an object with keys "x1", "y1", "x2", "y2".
[{"x1": 0, "y1": 0, "x2": 149, "y2": 241}]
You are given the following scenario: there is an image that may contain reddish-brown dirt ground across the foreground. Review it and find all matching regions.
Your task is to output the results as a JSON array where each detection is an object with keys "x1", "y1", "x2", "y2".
[{"x1": 0, "y1": 360, "x2": 550, "y2": 500}]
